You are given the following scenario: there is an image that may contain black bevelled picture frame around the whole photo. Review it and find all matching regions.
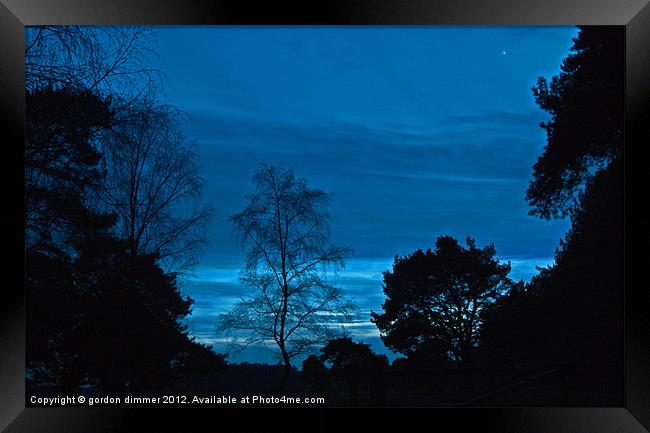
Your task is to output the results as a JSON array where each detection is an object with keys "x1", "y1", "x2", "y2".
[{"x1": 0, "y1": 0, "x2": 650, "y2": 433}]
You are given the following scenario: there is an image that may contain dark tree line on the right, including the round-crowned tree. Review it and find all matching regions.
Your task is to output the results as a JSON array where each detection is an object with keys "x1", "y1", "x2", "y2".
[{"x1": 364, "y1": 26, "x2": 624, "y2": 404}]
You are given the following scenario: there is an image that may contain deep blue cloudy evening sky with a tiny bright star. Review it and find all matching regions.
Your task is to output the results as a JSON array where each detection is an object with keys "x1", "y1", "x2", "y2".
[{"x1": 151, "y1": 27, "x2": 577, "y2": 362}]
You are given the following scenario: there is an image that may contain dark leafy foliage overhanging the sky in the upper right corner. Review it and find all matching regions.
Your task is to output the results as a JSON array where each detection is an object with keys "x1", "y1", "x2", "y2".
[{"x1": 526, "y1": 26, "x2": 625, "y2": 219}]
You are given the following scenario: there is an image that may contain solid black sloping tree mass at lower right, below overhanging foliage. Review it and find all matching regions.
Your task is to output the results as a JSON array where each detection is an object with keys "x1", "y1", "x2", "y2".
[{"x1": 483, "y1": 162, "x2": 624, "y2": 366}]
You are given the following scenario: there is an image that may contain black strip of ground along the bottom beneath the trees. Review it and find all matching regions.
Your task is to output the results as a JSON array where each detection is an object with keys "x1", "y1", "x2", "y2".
[{"x1": 26, "y1": 364, "x2": 623, "y2": 407}]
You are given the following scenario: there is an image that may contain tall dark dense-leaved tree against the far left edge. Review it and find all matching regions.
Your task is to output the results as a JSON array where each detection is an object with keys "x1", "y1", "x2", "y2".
[{"x1": 25, "y1": 87, "x2": 119, "y2": 389}]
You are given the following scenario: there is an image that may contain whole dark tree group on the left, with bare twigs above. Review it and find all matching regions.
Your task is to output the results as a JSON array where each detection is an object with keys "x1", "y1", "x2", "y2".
[{"x1": 25, "y1": 26, "x2": 224, "y2": 392}]
